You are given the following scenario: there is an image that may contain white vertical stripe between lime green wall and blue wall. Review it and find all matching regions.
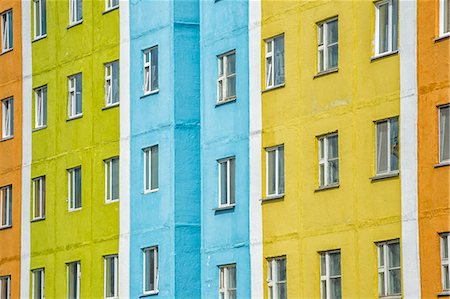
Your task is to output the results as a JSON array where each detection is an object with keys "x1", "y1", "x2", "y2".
[{"x1": 119, "y1": 0, "x2": 131, "y2": 298}]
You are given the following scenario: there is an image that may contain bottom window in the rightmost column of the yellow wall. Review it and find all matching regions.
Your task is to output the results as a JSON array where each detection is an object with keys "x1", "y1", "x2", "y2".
[{"x1": 377, "y1": 240, "x2": 402, "y2": 297}]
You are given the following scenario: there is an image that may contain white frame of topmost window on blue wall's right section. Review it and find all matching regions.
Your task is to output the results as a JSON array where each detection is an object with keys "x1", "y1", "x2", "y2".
[{"x1": 217, "y1": 50, "x2": 237, "y2": 103}]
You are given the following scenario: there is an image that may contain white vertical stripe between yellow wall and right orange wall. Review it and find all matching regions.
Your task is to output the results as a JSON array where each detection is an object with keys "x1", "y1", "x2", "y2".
[{"x1": 399, "y1": 0, "x2": 421, "y2": 298}]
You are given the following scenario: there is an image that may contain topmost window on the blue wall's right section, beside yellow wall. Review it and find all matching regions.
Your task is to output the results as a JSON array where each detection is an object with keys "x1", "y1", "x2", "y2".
[{"x1": 217, "y1": 51, "x2": 236, "y2": 102}]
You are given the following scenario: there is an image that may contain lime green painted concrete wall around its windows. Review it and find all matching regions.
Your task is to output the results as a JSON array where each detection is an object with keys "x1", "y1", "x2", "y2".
[{"x1": 30, "y1": 1, "x2": 119, "y2": 298}]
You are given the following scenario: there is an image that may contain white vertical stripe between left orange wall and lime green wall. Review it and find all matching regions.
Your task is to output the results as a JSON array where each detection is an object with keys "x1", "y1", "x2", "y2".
[{"x1": 20, "y1": 0, "x2": 32, "y2": 298}]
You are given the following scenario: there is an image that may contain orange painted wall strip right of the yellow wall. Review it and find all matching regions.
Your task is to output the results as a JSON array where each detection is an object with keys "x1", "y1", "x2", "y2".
[{"x1": 417, "y1": 0, "x2": 450, "y2": 298}]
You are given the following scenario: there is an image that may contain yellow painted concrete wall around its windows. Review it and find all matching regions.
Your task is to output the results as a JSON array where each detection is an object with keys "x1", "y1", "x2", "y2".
[{"x1": 261, "y1": 0, "x2": 401, "y2": 298}]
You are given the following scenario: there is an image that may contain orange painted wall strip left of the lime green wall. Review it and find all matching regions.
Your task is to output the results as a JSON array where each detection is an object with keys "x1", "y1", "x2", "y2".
[{"x1": 0, "y1": 0, "x2": 22, "y2": 298}]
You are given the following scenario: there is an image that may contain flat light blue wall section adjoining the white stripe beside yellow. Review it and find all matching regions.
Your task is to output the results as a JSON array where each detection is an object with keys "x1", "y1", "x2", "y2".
[{"x1": 200, "y1": 0, "x2": 251, "y2": 299}]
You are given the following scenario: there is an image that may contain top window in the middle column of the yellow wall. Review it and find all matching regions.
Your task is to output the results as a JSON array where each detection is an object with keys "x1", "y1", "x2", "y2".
[{"x1": 317, "y1": 18, "x2": 338, "y2": 73}]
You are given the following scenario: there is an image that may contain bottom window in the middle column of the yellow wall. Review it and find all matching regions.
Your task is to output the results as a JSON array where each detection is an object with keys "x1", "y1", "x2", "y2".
[{"x1": 320, "y1": 250, "x2": 342, "y2": 299}]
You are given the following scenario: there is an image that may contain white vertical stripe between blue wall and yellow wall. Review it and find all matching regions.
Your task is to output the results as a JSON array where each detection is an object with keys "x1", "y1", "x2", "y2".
[{"x1": 248, "y1": 0, "x2": 263, "y2": 298}]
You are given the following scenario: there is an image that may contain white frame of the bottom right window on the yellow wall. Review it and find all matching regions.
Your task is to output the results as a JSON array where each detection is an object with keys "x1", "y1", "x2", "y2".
[{"x1": 376, "y1": 240, "x2": 402, "y2": 298}]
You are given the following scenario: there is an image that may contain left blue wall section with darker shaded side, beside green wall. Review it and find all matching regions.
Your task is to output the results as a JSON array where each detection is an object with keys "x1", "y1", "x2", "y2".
[{"x1": 129, "y1": 0, "x2": 200, "y2": 298}]
